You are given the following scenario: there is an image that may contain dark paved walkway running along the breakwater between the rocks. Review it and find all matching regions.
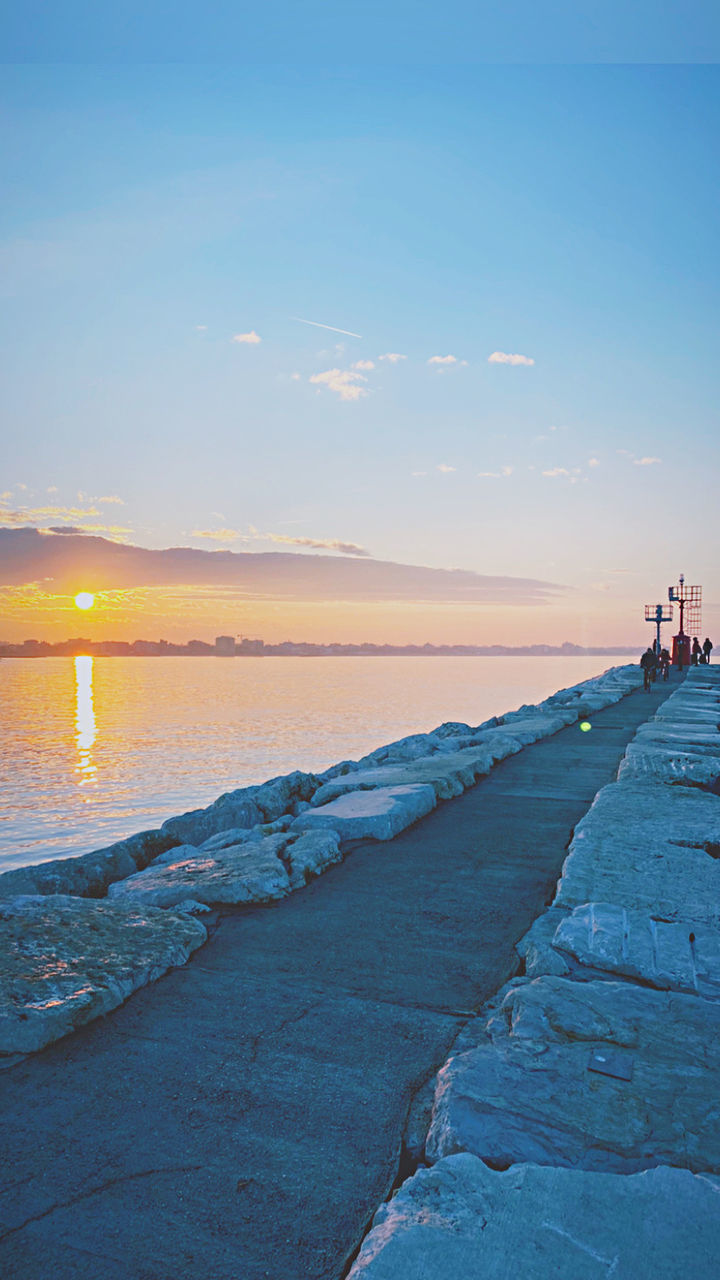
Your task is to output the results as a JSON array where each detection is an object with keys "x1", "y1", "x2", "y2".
[{"x1": 0, "y1": 680, "x2": 676, "y2": 1280}]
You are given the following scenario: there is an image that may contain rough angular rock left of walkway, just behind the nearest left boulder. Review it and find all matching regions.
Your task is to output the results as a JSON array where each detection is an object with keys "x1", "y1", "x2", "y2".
[{"x1": 109, "y1": 835, "x2": 291, "y2": 908}]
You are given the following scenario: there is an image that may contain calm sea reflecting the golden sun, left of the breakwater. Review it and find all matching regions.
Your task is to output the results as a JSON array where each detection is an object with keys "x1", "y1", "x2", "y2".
[{"x1": 0, "y1": 655, "x2": 637, "y2": 869}]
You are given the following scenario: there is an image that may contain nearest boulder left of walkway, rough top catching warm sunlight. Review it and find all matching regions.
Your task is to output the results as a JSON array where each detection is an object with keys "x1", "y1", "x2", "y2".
[{"x1": 0, "y1": 895, "x2": 206, "y2": 1055}]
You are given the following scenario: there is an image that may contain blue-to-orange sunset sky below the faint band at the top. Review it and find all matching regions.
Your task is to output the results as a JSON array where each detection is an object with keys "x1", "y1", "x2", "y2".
[{"x1": 0, "y1": 46, "x2": 720, "y2": 646}]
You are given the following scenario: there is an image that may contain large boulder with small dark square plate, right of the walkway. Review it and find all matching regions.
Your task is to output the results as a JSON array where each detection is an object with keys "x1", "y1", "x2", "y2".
[{"x1": 425, "y1": 977, "x2": 720, "y2": 1172}]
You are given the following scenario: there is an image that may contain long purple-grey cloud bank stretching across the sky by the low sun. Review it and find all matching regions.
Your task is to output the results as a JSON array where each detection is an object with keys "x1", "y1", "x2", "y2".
[{"x1": 0, "y1": 527, "x2": 568, "y2": 605}]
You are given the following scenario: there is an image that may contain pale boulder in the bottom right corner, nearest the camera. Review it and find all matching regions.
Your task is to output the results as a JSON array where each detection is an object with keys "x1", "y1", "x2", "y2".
[{"x1": 348, "y1": 1155, "x2": 720, "y2": 1280}]
